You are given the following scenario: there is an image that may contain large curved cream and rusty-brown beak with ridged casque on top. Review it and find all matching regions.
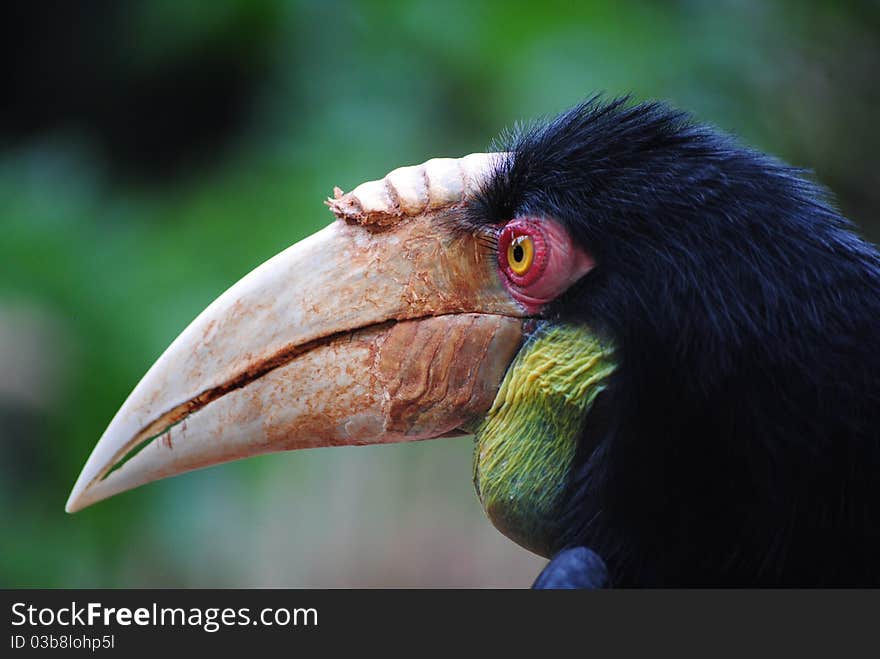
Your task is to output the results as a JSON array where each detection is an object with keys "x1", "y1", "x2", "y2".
[{"x1": 67, "y1": 154, "x2": 523, "y2": 512}]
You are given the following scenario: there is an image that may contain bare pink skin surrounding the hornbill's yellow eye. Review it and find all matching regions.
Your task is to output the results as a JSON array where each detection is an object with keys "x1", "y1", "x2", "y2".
[{"x1": 498, "y1": 218, "x2": 596, "y2": 314}]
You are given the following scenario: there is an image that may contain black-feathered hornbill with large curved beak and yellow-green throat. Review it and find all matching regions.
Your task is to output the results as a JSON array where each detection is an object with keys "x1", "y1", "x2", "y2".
[{"x1": 67, "y1": 98, "x2": 880, "y2": 587}]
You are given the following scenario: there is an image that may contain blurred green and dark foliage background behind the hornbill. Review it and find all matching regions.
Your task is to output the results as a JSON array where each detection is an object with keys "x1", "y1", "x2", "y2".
[{"x1": 0, "y1": 0, "x2": 880, "y2": 587}]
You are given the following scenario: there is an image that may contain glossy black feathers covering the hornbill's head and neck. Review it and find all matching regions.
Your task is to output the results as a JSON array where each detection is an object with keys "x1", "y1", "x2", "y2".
[{"x1": 465, "y1": 99, "x2": 880, "y2": 585}]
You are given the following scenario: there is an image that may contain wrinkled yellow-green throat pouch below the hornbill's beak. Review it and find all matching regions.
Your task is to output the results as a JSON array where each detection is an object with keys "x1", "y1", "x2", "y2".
[{"x1": 474, "y1": 321, "x2": 615, "y2": 557}]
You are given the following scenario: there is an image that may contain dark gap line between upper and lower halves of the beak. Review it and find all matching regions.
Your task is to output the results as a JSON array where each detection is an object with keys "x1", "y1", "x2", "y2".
[{"x1": 83, "y1": 311, "x2": 516, "y2": 493}]
